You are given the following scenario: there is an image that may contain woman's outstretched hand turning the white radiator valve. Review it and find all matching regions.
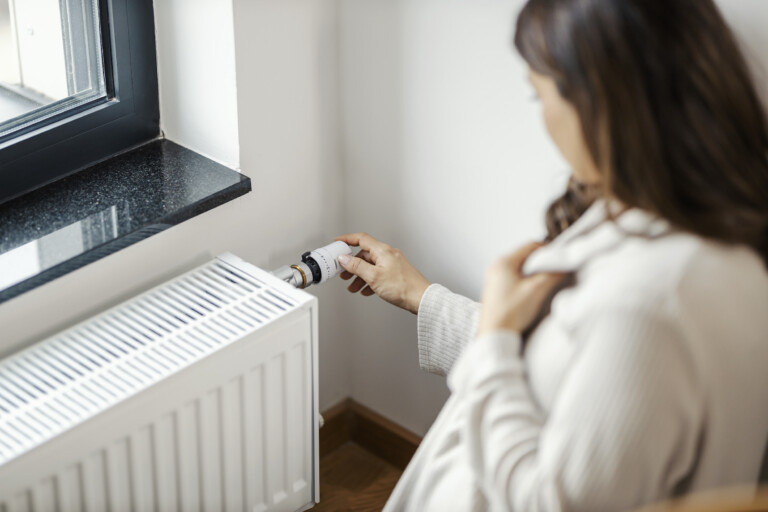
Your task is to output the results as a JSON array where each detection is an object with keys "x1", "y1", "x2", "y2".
[{"x1": 336, "y1": 233, "x2": 429, "y2": 314}]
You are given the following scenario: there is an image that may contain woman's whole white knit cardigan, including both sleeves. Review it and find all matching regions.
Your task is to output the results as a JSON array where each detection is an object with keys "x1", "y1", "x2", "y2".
[{"x1": 384, "y1": 202, "x2": 768, "y2": 512}]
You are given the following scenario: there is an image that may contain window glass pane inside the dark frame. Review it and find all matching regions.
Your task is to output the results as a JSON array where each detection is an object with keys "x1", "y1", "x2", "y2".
[{"x1": 0, "y1": 0, "x2": 107, "y2": 141}]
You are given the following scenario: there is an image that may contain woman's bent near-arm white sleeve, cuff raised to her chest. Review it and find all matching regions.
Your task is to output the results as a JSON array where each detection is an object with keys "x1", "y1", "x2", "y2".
[{"x1": 448, "y1": 311, "x2": 705, "y2": 512}]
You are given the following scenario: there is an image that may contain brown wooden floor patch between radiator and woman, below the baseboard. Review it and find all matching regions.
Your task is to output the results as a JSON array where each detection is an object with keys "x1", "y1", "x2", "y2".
[{"x1": 312, "y1": 442, "x2": 402, "y2": 512}]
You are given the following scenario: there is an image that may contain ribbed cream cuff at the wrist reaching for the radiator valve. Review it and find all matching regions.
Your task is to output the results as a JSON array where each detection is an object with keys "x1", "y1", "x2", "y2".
[{"x1": 418, "y1": 284, "x2": 480, "y2": 375}]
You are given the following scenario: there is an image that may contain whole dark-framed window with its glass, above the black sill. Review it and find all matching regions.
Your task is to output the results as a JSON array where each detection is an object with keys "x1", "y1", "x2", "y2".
[{"x1": 0, "y1": 0, "x2": 159, "y2": 202}]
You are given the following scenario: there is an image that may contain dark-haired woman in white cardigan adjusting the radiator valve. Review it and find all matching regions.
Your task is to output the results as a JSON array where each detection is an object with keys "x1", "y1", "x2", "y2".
[{"x1": 340, "y1": 0, "x2": 768, "y2": 511}]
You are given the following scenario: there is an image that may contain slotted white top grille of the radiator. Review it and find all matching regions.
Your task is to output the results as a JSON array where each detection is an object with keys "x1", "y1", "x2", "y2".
[{"x1": 0, "y1": 255, "x2": 300, "y2": 465}]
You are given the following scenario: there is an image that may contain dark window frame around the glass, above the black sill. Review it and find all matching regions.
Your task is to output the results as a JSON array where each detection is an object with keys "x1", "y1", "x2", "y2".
[{"x1": 0, "y1": 0, "x2": 160, "y2": 204}]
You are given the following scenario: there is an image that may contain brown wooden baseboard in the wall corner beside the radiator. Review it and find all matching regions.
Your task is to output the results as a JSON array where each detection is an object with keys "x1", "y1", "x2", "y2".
[{"x1": 320, "y1": 398, "x2": 421, "y2": 469}]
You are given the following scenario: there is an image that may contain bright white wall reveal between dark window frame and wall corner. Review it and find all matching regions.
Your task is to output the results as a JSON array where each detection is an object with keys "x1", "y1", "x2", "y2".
[{"x1": 155, "y1": 0, "x2": 240, "y2": 169}]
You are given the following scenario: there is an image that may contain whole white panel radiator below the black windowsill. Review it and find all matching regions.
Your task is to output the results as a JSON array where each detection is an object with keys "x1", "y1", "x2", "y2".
[{"x1": 0, "y1": 255, "x2": 320, "y2": 512}]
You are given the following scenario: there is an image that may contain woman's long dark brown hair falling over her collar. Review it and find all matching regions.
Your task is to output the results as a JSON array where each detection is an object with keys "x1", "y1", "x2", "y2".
[{"x1": 515, "y1": 0, "x2": 768, "y2": 265}]
